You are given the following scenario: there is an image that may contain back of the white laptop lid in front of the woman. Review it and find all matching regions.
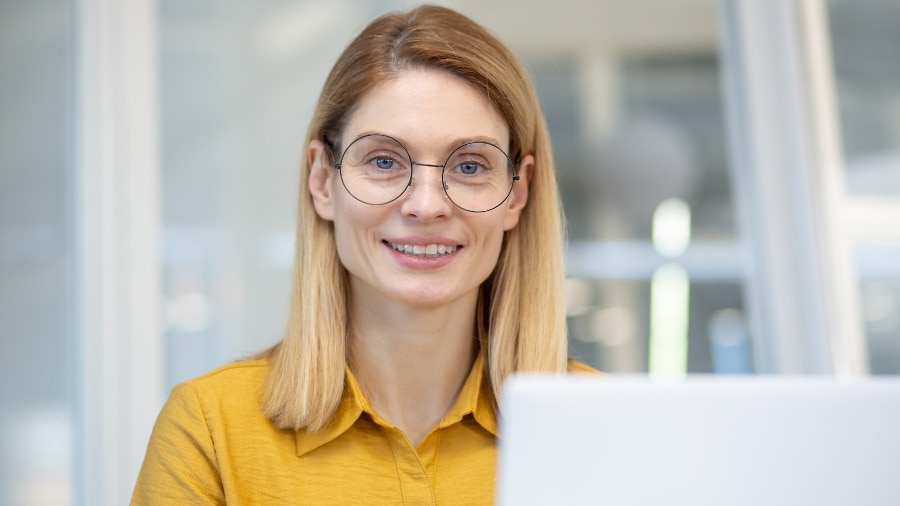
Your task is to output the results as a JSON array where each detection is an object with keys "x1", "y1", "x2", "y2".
[{"x1": 497, "y1": 375, "x2": 900, "y2": 506}]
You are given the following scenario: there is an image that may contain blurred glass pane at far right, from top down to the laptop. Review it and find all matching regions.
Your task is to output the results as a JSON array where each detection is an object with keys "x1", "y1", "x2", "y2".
[{"x1": 828, "y1": 0, "x2": 900, "y2": 374}]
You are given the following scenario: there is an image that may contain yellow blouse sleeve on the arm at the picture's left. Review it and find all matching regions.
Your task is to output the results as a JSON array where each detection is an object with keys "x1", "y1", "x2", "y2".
[{"x1": 131, "y1": 384, "x2": 225, "y2": 505}]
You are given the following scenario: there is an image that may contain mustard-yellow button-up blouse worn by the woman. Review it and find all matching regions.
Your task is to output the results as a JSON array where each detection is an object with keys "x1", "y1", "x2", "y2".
[{"x1": 131, "y1": 356, "x2": 590, "y2": 505}]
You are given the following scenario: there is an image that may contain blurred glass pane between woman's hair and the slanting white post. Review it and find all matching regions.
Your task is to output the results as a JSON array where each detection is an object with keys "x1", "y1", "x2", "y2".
[{"x1": 514, "y1": 2, "x2": 752, "y2": 373}]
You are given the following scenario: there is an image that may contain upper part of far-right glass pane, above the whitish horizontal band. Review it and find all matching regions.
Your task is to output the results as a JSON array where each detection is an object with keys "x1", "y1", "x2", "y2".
[{"x1": 828, "y1": 0, "x2": 900, "y2": 197}]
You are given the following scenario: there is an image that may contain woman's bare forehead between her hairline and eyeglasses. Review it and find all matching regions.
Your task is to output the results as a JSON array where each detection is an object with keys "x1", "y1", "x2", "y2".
[{"x1": 343, "y1": 69, "x2": 509, "y2": 155}]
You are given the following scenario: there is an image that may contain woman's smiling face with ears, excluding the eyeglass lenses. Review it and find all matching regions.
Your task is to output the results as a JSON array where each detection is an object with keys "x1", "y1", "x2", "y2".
[{"x1": 308, "y1": 69, "x2": 534, "y2": 307}]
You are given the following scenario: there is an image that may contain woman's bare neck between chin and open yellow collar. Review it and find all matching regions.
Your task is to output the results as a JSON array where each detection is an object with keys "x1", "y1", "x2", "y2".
[{"x1": 349, "y1": 293, "x2": 477, "y2": 446}]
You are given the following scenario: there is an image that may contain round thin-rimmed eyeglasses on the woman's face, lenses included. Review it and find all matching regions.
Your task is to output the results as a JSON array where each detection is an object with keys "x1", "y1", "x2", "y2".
[{"x1": 334, "y1": 134, "x2": 519, "y2": 213}]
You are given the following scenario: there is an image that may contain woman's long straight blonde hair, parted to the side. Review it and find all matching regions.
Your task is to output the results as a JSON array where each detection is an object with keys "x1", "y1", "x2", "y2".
[{"x1": 263, "y1": 5, "x2": 566, "y2": 431}]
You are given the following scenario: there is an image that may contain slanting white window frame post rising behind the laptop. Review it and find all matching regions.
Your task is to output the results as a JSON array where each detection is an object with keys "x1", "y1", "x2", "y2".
[{"x1": 720, "y1": 0, "x2": 866, "y2": 374}]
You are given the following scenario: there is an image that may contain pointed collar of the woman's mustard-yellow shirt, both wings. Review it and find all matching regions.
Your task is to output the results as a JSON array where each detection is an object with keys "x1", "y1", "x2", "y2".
[{"x1": 296, "y1": 353, "x2": 497, "y2": 457}]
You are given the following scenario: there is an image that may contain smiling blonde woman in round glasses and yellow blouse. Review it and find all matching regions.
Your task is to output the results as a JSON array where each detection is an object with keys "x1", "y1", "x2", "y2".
[{"x1": 133, "y1": 6, "x2": 585, "y2": 504}]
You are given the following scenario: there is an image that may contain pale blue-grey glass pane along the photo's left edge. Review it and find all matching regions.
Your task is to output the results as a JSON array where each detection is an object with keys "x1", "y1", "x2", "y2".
[{"x1": 0, "y1": 0, "x2": 77, "y2": 505}]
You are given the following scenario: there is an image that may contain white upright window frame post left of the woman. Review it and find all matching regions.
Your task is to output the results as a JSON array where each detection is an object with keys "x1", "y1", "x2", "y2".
[{"x1": 76, "y1": 0, "x2": 162, "y2": 504}]
